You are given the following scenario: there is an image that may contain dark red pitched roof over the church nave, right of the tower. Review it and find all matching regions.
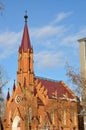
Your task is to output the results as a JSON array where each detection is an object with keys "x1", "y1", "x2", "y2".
[{"x1": 37, "y1": 77, "x2": 76, "y2": 99}]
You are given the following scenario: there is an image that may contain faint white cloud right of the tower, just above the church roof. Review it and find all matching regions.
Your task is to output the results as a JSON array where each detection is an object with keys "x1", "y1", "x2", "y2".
[{"x1": 34, "y1": 51, "x2": 65, "y2": 69}]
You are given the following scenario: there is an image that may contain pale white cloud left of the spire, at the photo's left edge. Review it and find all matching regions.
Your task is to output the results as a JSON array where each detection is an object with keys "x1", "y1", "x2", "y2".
[{"x1": 0, "y1": 31, "x2": 21, "y2": 59}]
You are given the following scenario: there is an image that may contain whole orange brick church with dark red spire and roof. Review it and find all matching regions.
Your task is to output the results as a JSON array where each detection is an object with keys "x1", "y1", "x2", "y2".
[{"x1": 4, "y1": 15, "x2": 79, "y2": 130}]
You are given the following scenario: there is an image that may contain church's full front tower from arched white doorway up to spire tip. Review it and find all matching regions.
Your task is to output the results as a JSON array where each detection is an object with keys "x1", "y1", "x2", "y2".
[{"x1": 4, "y1": 14, "x2": 36, "y2": 130}]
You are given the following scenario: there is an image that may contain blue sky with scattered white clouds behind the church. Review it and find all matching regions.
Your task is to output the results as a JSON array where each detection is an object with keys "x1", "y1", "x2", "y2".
[{"x1": 0, "y1": 0, "x2": 86, "y2": 95}]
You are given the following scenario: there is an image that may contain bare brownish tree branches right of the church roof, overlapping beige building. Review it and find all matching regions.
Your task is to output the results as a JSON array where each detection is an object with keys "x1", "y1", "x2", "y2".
[{"x1": 66, "y1": 63, "x2": 86, "y2": 113}]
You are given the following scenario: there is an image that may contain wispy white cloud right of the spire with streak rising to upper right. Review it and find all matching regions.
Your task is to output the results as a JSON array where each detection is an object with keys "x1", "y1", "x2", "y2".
[{"x1": 31, "y1": 12, "x2": 72, "y2": 38}]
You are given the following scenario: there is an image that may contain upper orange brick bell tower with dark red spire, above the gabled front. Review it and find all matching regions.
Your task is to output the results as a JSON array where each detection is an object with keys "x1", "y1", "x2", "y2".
[{"x1": 17, "y1": 14, "x2": 34, "y2": 89}]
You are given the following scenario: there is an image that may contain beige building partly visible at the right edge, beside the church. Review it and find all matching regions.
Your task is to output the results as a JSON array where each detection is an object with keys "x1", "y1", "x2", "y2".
[{"x1": 78, "y1": 38, "x2": 86, "y2": 130}]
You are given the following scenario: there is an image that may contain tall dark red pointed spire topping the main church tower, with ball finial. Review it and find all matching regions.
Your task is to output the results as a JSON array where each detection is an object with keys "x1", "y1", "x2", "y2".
[{"x1": 19, "y1": 12, "x2": 32, "y2": 53}]
